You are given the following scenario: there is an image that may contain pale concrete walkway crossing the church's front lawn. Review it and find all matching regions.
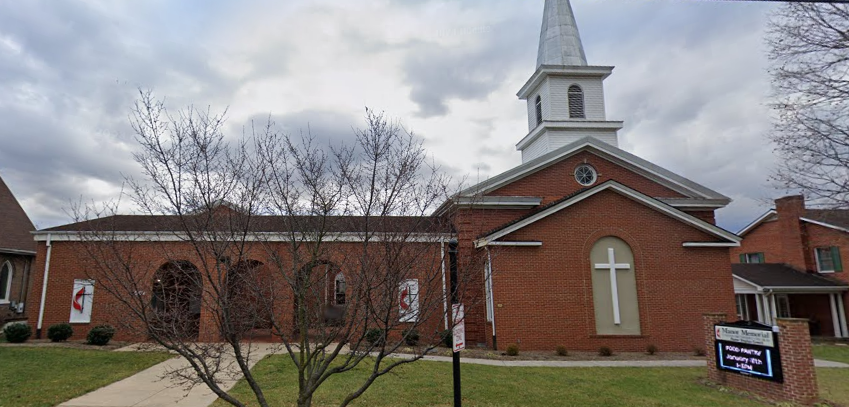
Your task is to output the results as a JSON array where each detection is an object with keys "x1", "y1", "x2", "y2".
[{"x1": 59, "y1": 345, "x2": 849, "y2": 407}]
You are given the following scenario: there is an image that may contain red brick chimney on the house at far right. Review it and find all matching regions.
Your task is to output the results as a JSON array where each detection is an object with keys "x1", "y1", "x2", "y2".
[{"x1": 775, "y1": 195, "x2": 813, "y2": 270}]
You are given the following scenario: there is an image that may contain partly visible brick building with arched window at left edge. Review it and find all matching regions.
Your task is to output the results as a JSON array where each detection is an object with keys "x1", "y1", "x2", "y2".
[{"x1": 0, "y1": 178, "x2": 36, "y2": 325}]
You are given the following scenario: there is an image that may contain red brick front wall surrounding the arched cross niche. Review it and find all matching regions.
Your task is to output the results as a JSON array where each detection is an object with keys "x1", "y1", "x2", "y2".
[{"x1": 476, "y1": 191, "x2": 735, "y2": 352}]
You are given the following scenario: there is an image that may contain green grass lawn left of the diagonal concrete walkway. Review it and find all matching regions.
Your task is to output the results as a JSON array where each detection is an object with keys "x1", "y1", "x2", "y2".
[{"x1": 0, "y1": 347, "x2": 171, "y2": 407}]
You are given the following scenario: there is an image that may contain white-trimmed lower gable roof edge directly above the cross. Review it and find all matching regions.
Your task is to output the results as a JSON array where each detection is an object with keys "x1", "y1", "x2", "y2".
[{"x1": 475, "y1": 180, "x2": 741, "y2": 247}]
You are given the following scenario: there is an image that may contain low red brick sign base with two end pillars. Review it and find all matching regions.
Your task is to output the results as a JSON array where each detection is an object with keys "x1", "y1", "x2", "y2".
[{"x1": 704, "y1": 314, "x2": 819, "y2": 405}]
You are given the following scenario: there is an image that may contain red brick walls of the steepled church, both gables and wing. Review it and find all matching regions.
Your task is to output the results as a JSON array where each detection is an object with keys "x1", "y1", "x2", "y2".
[{"x1": 28, "y1": 151, "x2": 734, "y2": 351}]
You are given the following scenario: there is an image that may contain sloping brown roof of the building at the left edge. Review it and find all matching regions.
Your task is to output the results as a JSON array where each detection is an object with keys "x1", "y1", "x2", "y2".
[{"x1": 0, "y1": 178, "x2": 36, "y2": 254}]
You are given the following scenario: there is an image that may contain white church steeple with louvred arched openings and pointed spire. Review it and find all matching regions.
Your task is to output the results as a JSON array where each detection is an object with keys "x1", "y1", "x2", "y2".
[{"x1": 516, "y1": 0, "x2": 622, "y2": 162}]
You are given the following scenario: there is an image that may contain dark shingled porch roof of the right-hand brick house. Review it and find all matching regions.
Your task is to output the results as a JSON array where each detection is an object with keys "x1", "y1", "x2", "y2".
[{"x1": 731, "y1": 263, "x2": 849, "y2": 292}]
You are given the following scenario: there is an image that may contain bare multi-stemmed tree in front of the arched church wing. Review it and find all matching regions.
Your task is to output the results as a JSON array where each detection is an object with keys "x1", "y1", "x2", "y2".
[{"x1": 71, "y1": 92, "x2": 482, "y2": 406}]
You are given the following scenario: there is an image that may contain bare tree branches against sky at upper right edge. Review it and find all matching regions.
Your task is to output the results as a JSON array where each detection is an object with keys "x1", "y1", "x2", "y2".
[{"x1": 767, "y1": 2, "x2": 849, "y2": 207}]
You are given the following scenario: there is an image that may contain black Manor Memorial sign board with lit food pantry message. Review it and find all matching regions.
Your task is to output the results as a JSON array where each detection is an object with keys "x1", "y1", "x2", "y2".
[{"x1": 714, "y1": 322, "x2": 784, "y2": 383}]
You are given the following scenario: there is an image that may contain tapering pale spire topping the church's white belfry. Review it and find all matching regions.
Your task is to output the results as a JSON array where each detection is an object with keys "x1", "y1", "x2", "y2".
[{"x1": 537, "y1": 0, "x2": 587, "y2": 68}]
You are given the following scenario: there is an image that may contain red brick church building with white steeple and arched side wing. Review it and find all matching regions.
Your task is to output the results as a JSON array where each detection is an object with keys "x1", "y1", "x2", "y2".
[{"x1": 28, "y1": 0, "x2": 740, "y2": 351}]
